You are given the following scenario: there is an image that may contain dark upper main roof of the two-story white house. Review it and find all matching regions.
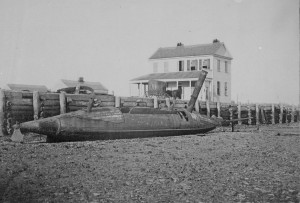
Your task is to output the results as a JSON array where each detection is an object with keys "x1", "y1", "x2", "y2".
[{"x1": 149, "y1": 42, "x2": 232, "y2": 59}]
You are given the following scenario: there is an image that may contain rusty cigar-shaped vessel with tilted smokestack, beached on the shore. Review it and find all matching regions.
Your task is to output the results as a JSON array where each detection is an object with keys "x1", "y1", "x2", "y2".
[{"x1": 11, "y1": 71, "x2": 219, "y2": 142}]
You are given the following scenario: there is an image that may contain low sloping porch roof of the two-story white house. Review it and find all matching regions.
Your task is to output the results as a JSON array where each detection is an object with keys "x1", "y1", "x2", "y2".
[{"x1": 131, "y1": 71, "x2": 205, "y2": 81}]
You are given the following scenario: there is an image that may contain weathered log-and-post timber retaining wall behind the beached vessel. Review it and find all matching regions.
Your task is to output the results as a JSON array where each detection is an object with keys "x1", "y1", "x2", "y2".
[{"x1": 0, "y1": 90, "x2": 300, "y2": 136}]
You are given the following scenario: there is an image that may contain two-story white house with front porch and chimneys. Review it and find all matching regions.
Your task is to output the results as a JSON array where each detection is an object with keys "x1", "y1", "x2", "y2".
[{"x1": 130, "y1": 40, "x2": 232, "y2": 103}]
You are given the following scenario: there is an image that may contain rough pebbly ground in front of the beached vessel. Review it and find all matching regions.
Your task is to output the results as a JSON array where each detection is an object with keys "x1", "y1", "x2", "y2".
[{"x1": 0, "y1": 123, "x2": 300, "y2": 202}]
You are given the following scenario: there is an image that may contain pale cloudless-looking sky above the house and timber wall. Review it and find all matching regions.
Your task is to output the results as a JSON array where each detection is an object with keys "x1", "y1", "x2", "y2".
[{"x1": 0, "y1": 0, "x2": 299, "y2": 104}]
